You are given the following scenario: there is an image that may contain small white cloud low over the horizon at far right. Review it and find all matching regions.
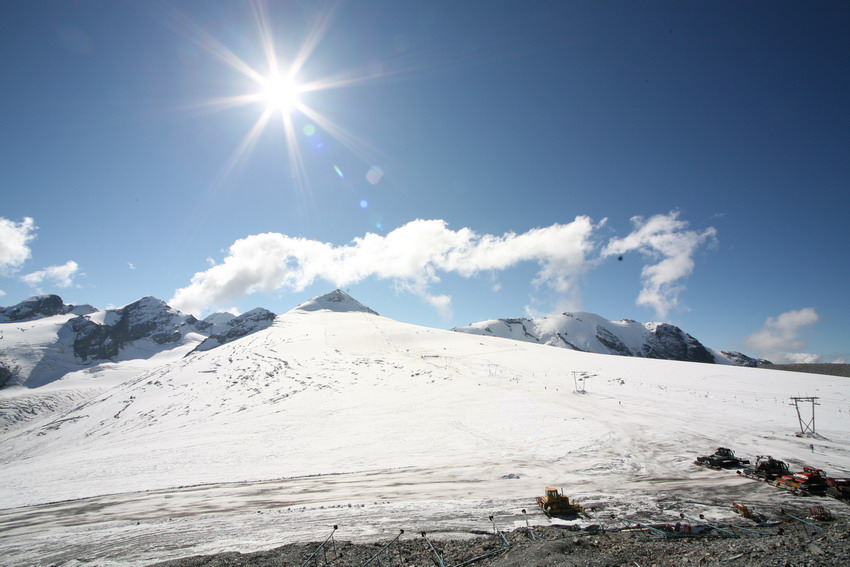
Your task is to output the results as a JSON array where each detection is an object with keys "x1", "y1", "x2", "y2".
[{"x1": 745, "y1": 307, "x2": 820, "y2": 362}]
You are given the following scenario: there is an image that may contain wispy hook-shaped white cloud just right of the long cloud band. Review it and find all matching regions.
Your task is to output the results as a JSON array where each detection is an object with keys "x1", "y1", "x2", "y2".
[{"x1": 602, "y1": 211, "x2": 717, "y2": 318}]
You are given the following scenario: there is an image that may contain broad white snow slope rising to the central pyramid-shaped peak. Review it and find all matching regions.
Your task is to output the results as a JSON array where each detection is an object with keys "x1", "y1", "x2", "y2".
[{"x1": 0, "y1": 292, "x2": 850, "y2": 565}]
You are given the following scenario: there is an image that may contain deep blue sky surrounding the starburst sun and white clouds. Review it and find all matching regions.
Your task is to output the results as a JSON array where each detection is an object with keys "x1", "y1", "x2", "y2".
[{"x1": 0, "y1": 0, "x2": 850, "y2": 361}]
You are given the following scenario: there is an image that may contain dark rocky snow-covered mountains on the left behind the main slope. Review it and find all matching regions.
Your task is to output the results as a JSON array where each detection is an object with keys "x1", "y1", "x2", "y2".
[{"x1": 0, "y1": 295, "x2": 274, "y2": 429}]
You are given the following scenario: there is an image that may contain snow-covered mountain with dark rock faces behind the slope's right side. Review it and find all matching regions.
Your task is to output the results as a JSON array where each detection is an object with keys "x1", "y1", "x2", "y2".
[{"x1": 452, "y1": 313, "x2": 766, "y2": 366}]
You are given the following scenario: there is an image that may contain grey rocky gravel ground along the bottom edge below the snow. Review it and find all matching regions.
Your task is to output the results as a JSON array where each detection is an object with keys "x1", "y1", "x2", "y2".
[{"x1": 156, "y1": 518, "x2": 850, "y2": 567}]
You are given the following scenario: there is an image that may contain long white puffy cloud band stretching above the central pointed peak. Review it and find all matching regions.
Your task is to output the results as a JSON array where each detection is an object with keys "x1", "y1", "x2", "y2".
[{"x1": 169, "y1": 216, "x2": 604, "y2": 314}]
